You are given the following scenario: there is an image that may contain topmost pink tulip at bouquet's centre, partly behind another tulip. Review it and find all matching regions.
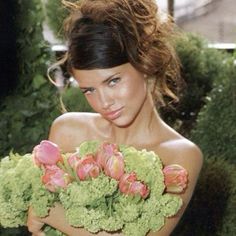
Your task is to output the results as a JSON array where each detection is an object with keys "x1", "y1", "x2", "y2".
[{"x1": 95, "y1": 142, "x2": 119, "y2": 168}]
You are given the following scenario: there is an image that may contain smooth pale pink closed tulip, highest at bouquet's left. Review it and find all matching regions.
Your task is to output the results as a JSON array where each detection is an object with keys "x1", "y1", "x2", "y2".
[{"x1": 33, "y1": 140, "x2": 62, "y2": 166}]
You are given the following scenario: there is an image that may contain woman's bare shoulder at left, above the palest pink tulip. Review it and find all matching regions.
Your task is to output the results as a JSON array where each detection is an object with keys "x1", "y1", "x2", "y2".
[{"x1": 49, "y1": 112, "x2": 97, "y2": 152}]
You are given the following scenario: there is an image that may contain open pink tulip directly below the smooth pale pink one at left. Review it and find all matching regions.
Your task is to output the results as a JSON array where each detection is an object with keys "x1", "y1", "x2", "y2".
[{"x1": 42, "y1": 165, "x2": 71, "y2": 192}]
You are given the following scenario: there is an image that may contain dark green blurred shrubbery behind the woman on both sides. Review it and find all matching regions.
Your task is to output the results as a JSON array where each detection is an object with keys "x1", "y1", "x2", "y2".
[{"x1": 0, "y1": 0, "x2": 236, "y2": 236}]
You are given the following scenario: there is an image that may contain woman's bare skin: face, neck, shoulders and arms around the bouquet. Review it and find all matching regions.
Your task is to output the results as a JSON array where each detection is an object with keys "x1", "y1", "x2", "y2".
[{"x1": 27, "y1": 63, "x2": 202, "y2": 236}]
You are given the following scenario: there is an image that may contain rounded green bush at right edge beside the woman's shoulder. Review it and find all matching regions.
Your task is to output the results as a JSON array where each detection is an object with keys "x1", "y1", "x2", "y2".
[{"x1": 192, "y1": 56, "x2": 236, "y2": 163}]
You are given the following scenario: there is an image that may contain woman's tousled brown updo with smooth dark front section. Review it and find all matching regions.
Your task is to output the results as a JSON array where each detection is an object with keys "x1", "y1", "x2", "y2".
[{"x1": 59, "y1": 0, "x2": 180, "y2": 105}]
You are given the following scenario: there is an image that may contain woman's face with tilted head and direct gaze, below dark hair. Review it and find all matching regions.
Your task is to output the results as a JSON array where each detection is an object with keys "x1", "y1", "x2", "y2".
[{"x1": 73, "y1": 63, "x2": 147, "y2": 127}]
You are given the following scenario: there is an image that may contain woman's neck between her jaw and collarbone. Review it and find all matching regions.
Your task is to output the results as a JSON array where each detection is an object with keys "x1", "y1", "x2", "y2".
[{"x1": 110, "y1": 93, "x2": 160, "y2": 147}]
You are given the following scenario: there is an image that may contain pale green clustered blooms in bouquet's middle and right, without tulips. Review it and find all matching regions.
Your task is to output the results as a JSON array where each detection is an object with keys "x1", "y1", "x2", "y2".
[{"x1": 59, "y1": 141, "x2": 182, "y2": 236}]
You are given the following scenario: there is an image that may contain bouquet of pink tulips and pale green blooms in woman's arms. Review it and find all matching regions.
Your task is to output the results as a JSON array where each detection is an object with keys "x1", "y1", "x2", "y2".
[{"x1": 0, "y1": 140, "x2": 187, "y2": 236}]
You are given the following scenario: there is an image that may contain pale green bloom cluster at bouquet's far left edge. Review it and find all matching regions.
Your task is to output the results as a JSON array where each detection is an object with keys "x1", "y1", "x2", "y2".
[{"x1": 0, "y1": 153, "x2": 54, "y2": 227}]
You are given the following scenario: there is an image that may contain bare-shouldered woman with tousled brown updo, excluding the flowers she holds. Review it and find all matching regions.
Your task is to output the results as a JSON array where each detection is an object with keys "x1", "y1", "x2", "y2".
[{"x1": 28, "y1": 0, "x2": 202, "y2": 236}]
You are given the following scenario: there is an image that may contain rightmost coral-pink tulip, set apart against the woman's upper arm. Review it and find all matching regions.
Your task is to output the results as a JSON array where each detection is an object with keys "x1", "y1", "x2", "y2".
[{"x1": 163, "y1": 164, "x2": 188, "y2": 193}]
